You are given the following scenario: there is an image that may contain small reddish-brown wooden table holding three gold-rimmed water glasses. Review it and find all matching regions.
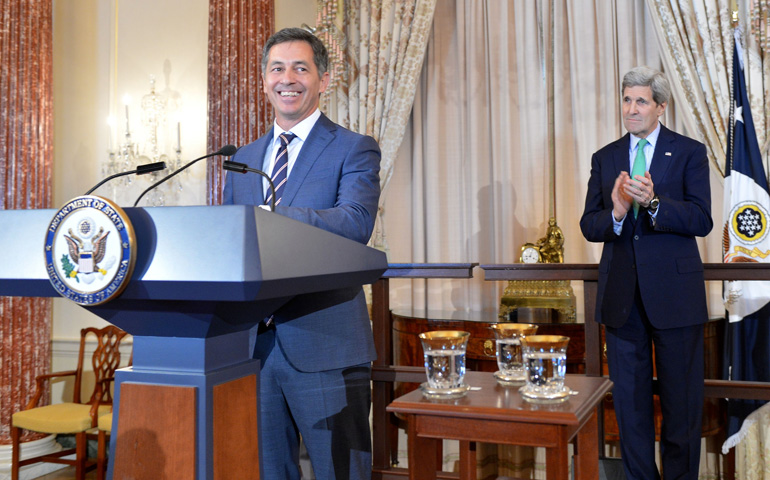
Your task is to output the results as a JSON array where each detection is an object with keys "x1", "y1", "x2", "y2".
[{"x1": 387, "y1": 372, "x2": 612, "y2": 480}]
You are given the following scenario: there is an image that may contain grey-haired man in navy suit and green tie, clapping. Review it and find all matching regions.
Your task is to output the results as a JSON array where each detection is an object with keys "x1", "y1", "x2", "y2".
[{"x1": 580, "y1": 67, "x2": 713, "y2": 480}]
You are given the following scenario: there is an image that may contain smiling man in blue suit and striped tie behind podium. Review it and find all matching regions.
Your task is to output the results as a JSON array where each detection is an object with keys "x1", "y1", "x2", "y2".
[{"x1": 224, "y1": 28, "x2": 380, "y2": 480}]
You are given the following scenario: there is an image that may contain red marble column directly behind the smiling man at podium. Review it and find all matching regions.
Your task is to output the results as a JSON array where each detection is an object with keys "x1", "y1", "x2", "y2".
[{"x1": 206, "y1": 0, "x2": 275, "y2": 205}]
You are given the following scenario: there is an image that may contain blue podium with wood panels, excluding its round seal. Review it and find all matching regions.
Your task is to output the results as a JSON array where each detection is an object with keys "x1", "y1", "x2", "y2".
[{"x1": 0, "y1": 205, "x2": 387, "y2": 480}]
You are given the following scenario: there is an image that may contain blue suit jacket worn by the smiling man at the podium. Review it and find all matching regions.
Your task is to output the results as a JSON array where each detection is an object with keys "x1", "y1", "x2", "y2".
[{"x1": 224, "y1": 114, "x2": 380, "y2": 372}]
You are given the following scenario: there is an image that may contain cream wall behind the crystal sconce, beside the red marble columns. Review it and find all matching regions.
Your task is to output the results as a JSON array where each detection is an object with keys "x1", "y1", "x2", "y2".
[{"x1": 48, "y1": 0, "x2": 316, "y2": 401}]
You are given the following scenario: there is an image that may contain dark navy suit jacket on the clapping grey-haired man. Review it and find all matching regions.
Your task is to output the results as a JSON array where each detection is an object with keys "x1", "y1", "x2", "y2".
[{"x1": 580, "y1": 125, "x2": 713, "y2": 328}]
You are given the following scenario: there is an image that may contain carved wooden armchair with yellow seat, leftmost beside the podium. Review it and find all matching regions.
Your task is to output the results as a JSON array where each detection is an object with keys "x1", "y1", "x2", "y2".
[{"x1": 11, "y1": 325, "x2": 127, "y2": 480}]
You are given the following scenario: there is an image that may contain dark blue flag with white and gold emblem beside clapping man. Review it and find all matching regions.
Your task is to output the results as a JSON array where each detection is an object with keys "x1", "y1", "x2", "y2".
[{"x1": 722, "y1": 30, "x2": 770, "y2": 452}]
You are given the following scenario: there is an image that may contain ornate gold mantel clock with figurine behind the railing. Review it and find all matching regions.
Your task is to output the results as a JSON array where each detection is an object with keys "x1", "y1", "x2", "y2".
[{"x1": 498, "y1": 217, "x2": 576, "y2": 323}]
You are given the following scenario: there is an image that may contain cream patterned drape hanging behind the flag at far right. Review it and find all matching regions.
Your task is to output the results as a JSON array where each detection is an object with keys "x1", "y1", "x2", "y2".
[{"x1": 647, "y1": 0, "x2": 770, "y2": 176}]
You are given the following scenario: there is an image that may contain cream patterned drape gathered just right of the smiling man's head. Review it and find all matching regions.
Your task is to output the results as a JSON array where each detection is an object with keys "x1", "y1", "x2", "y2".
[{"x1": 318, "y1": 0, "x2": 436, "y2": 250}]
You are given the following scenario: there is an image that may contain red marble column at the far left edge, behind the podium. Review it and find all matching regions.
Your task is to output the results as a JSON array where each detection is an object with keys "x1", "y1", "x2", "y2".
[{"x1": 0, "y1": 0, "x2": 53, "y2": 444}]
